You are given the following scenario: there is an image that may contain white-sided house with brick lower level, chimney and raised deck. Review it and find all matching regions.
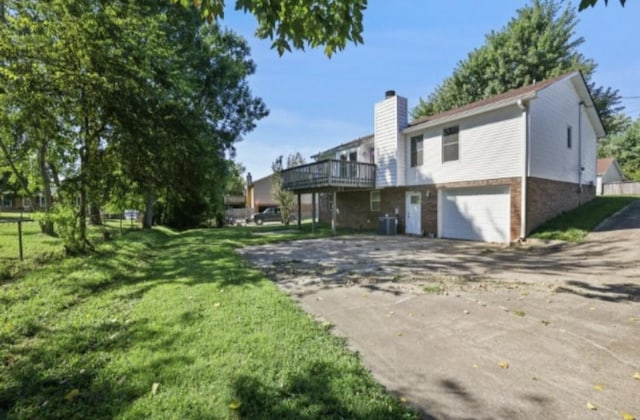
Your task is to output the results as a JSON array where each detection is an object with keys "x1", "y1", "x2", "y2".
[{"x1": 283, "y1": 72, "x2": 605, "y2": 242}]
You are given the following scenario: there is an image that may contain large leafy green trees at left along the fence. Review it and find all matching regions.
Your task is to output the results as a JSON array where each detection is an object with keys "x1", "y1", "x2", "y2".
[{"x1": 0, "y1": 0, "x2": 267, "y2": 248}]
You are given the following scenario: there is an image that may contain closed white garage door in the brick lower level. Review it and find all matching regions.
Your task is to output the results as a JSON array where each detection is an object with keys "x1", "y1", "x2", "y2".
[{"x1": 438, "y1": 186, "x2": 511, "y2": 242}]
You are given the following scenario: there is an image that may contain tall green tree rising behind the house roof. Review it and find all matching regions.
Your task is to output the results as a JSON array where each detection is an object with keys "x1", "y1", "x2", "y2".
[{"x1": 412, "y1": 0, "x2": 623, "y2": 132}]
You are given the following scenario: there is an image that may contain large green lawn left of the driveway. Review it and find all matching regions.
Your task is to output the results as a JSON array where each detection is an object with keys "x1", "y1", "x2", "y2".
[{"x1": 0, "y1": 221, "x2": 417, "y2": 419}]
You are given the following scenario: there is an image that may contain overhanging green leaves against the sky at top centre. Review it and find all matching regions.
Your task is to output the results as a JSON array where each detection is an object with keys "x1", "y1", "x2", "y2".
[{"x1": 172, "y1": 0, "x2": 367, "y2": 57}]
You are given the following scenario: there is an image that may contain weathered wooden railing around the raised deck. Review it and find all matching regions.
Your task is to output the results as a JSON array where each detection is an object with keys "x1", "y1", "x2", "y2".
[{"x1": 282, "y1": 159, "x2": 376, "y2": 191}]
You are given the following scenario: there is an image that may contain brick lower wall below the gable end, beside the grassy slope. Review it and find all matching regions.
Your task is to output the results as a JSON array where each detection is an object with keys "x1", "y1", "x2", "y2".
[{"x1": 527, "y1": 178, "x2": 596, "y2": 233}]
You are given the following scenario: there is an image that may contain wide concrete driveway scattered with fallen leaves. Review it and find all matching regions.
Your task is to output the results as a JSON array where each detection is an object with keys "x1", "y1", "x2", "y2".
[{"x1": 240, "y1": 200, "x2": 640, "y2": 419}]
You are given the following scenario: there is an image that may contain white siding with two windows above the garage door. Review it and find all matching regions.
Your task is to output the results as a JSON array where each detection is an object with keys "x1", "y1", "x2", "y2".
[{"x1": 405, "y1": 104, "x2": 526, "y2": 185}]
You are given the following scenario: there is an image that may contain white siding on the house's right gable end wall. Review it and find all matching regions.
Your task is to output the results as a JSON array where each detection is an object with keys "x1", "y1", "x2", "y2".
[{"x1": 530, "y1": 80, "x2": 597, "y2": 185}]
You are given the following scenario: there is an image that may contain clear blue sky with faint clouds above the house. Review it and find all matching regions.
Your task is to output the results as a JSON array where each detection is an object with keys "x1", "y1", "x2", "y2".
[{"x1": 221, "y1": 0, "x2": 640, "y2": 180}]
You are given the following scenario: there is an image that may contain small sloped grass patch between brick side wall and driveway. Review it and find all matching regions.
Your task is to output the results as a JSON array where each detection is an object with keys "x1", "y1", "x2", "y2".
[{"x1": 531, "y1": 196, "x2": 640, "y2": 242}]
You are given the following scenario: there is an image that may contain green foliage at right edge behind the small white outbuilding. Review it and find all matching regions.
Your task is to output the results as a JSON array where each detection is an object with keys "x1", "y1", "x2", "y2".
[{"x1": 598, "y1": 117, "x2": 640, "y2": 181}]
